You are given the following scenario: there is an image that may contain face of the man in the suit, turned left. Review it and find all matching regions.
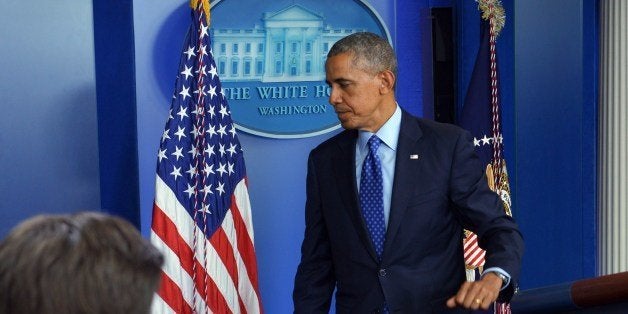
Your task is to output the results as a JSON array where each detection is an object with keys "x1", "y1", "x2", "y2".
[{"x1": 325, "y1": 53, "x2": 387, "y2": 132}]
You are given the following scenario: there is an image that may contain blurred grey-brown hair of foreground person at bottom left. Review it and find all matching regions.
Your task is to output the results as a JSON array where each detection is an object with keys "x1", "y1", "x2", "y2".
[{"x1": 0, "y1": 212, "x2": 163, "y2": 314}]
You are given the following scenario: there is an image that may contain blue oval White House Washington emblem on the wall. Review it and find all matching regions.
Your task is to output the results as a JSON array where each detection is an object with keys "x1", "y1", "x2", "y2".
[{"x1": 211, "y1": 0, "x2": 390, "y2": 138}]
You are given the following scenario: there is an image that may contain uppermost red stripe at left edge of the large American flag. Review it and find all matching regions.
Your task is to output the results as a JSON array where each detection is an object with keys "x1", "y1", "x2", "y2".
[{"x1": 153, "y1": 204, "x2": 231, "y2": 313}]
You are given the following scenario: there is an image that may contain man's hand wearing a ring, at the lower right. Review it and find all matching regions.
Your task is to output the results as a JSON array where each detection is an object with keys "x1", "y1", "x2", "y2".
[{"x1": 447, "y1": 272, "x2": 502, "y2": 310}]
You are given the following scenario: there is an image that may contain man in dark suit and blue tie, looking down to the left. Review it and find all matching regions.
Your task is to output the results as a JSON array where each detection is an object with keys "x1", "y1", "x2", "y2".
[{"x1": 293, "y1": 33, "x2": 523, "y2": 313}]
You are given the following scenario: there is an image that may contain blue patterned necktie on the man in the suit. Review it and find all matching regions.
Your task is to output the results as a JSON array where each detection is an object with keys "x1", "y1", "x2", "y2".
[{"x1": 359, "y1": 135, "x2": 386, "y2": 259}]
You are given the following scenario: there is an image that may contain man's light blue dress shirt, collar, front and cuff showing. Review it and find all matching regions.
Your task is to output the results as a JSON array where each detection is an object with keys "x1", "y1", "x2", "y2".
[{"x1": 355, "y1": 105, "x2": 510, "y2": 289}]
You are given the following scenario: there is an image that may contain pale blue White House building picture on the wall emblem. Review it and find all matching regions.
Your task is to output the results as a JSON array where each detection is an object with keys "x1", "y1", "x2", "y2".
[{"x1": 212, "y1": 4, "x2": 365, "y2": 82}]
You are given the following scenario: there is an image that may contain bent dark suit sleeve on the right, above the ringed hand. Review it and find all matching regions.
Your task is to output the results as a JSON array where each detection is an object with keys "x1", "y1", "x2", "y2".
[{"x1": 450, "y1": 132, "x2": 523, "y2": 301}]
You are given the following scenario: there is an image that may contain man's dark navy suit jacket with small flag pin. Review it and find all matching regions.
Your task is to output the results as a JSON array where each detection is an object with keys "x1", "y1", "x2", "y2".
[{"x1": 293, "y1": 112, "x2": 523, "y2": 313}]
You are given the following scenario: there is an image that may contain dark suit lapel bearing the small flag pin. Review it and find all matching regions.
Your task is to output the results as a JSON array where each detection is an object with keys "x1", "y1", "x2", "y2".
[{"x1": 384, "y1": 111, "x2": 423, "y2": 258}]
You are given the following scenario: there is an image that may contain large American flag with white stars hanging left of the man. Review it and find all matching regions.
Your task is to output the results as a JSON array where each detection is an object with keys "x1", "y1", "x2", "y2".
[{"x1": 151, "y1": 0, "x2": 262, "y2": 313}]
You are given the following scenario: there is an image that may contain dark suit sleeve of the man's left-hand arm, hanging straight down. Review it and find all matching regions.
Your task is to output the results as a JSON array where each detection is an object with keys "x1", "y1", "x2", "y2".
[{"x1": 293, "y1": 153, "x2": 336, "y2": 313}]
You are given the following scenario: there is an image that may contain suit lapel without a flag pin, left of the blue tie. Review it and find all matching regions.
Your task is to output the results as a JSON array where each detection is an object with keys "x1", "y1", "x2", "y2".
[{"x1": 333, "y1": 131, "x2": 377, "y2": 261}]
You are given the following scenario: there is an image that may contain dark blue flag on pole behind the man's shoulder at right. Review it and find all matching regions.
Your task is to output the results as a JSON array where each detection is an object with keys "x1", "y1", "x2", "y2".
[{"x1": 459, "y1": 0, "x2": 511, "y2": 313}]
